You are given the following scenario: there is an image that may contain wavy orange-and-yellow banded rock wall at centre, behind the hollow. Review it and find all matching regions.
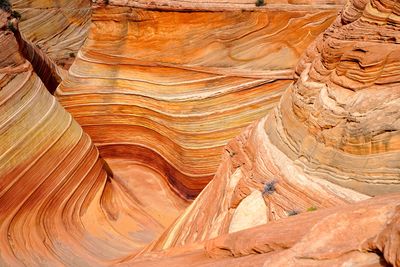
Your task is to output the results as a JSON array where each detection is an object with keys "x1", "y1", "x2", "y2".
[{"x1": 57, "y1": 1, "x2": 336, "y2": 199}]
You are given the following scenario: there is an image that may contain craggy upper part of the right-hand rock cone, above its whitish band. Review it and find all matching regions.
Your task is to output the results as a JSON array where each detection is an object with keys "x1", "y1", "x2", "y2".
[{"x1": 264, "y1": 0, "x2": 400, "y2": 196}]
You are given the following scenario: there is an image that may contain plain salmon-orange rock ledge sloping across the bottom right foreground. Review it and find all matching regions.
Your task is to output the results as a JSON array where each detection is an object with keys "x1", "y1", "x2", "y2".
[{"x1": 122, "y1": 193, "x2": 400, "y2": 267}]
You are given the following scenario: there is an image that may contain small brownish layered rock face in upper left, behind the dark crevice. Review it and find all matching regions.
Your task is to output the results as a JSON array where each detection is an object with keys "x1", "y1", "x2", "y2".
[{"x1": 10, "y1": 0, "x2": 91, "y2": 69}]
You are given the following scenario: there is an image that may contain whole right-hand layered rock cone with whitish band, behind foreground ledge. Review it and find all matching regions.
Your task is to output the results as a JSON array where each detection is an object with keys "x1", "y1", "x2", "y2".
[{"x1": 144, "y1": 0, "x2": 400, "y2": 256}]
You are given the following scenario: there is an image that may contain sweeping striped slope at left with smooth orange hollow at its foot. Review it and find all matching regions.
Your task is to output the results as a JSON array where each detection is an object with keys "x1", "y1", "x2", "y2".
[{"x1": 0, "y1": 7, "x2": 186, "y2": 266}]
